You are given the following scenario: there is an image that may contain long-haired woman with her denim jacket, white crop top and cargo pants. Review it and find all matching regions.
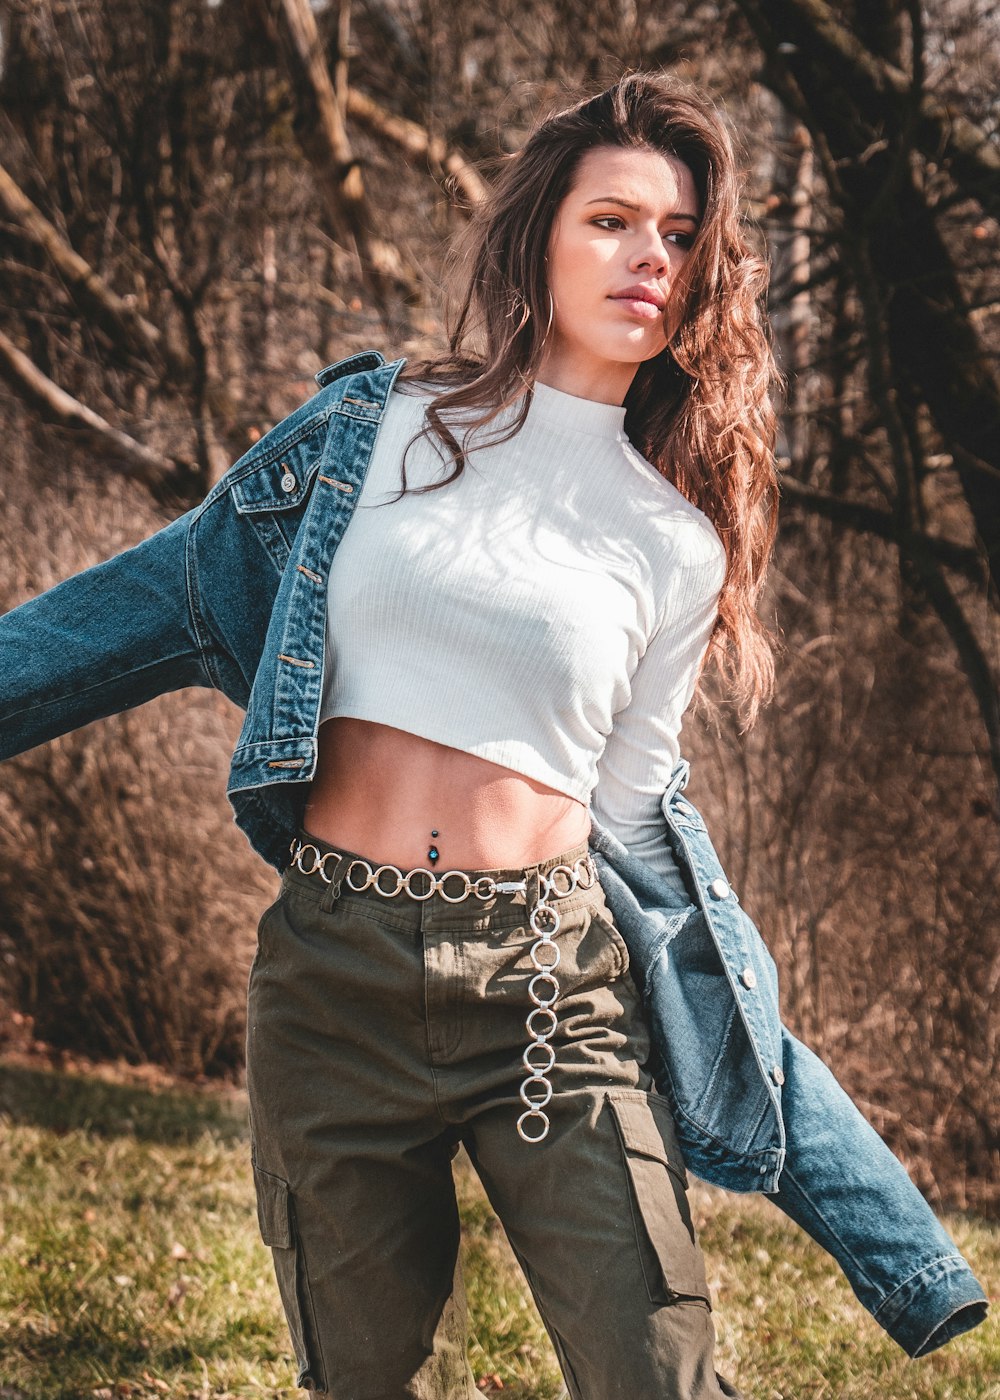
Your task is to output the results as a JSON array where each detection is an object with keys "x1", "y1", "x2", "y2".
[{"x1": 0, "y1": 74, "x2": 985, "y2": 1400}]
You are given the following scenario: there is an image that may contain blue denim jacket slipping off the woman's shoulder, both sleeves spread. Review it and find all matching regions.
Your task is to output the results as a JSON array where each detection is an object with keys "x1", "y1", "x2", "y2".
[{"x1": 0, "y1": 351, "x2": 986, "y2": 1357}]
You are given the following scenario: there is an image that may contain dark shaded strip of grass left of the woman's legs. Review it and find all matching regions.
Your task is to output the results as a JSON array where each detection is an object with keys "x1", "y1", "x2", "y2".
[{"x1": 0, "y1": 1064, "x2": 249, "y2": 1142}]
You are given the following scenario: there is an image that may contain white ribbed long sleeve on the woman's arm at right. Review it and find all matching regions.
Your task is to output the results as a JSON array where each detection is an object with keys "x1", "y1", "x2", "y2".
[{"x1": 591, "y1": 518, "x2": 725, "y2": 875}]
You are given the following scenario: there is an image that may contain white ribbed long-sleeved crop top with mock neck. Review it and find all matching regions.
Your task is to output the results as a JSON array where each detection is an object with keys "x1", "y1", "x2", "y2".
[{"x1": 321, "y1": 384, "x2": 725, "y2": 872}]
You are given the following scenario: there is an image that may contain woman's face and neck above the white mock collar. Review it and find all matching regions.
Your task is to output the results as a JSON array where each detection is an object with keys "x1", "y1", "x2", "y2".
[{"x1": 539, "y1": 146, "x2": 702, "y2": 403}]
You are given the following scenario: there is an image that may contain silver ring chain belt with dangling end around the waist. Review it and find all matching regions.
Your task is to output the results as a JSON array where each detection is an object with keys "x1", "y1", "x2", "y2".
[{"x1": 291, "y1": 840, "x2": 597, "y2": 1142}]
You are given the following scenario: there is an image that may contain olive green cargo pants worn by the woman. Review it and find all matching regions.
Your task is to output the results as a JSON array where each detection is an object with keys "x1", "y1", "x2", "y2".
[{"x1": 246, "y1": 837, "x2": 737, "y2": 1400}]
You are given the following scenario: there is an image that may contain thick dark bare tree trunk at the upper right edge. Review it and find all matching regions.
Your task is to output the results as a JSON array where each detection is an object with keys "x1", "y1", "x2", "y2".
[{"x1": 722, "y1": 0, "x2": 1000, "y2": 785}]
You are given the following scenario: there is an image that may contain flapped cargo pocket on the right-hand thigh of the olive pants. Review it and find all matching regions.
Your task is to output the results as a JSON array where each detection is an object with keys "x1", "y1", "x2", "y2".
[{"x1": 608, "y1": 1093, "x2": 711, "y2": 1308}]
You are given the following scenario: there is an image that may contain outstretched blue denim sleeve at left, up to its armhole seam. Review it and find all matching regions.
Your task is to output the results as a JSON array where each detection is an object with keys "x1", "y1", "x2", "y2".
[{"x1": 0, "y1": 512, "x2": 213, "y2": 759}]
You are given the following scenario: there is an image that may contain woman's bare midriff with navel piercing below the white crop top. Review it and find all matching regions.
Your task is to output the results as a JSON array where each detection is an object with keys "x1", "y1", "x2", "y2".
[{"x1": 304, "y1": 717, "x2": 590, "y2": 871}]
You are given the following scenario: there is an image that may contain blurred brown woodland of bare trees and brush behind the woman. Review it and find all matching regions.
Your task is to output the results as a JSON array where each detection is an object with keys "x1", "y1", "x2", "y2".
[{"x1": 0, "y1": 0, "x2": 1000, "y2": 1212}]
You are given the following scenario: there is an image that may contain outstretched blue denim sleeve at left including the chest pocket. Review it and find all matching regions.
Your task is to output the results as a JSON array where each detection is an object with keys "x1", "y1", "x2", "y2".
[{"x1": 0, "y1": 347, "x2": 350, "y2": 759}]
